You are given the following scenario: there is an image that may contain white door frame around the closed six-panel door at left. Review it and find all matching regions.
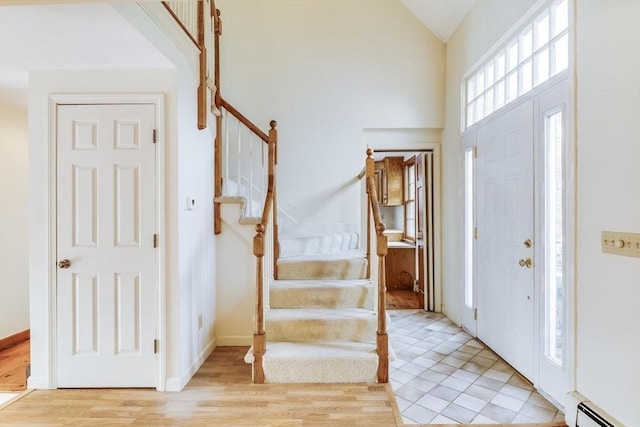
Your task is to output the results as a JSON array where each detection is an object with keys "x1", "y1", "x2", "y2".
[{"x1": 46, "y1": 94, "x2": 167, "y2": 391}]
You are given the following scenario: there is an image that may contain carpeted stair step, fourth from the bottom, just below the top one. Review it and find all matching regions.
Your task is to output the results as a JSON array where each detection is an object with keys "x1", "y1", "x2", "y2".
[{"x1": 278, "y1": 249, "x2": 367, "y2": 280}]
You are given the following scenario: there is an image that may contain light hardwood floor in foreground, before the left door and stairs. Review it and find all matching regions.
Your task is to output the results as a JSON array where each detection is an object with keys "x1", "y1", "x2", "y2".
[{"x1": 0, "y1": 347, "x2": 564, "y2": 427}]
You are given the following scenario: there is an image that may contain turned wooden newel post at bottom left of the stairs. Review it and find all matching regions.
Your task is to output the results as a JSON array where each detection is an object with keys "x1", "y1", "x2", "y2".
[{"x1": 253, "y1": 224, "x2": 266, "y2": 384}]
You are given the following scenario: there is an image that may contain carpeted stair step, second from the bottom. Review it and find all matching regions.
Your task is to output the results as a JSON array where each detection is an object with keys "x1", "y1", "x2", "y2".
[{"x1": 266, "y1": 308, "x2": 377, "y2": 343}]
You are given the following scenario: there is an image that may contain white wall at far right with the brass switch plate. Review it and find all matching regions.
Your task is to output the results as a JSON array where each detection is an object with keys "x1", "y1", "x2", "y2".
[{"x1": 576, "y1": 0, "x2": 640, "y2": 426}]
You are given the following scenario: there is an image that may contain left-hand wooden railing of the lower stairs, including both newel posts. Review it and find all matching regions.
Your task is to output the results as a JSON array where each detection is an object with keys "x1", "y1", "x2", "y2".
[{"x1": 253, "y1": 120, "x2": 278, "y2": 384}]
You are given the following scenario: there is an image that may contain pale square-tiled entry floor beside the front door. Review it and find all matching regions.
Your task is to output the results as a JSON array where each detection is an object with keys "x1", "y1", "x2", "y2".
[{"x1": 389, "y1": 310, "x2": 564, "y2": 424}]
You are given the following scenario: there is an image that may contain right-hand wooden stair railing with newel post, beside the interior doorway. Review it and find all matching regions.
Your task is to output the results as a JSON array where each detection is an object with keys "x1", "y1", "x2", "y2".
[{"x1": 358, "y1": 148, "x2": 389, "y2": 383}]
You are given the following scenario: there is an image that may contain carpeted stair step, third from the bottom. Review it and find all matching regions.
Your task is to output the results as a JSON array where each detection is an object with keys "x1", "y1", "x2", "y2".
[{"x1": 269, "y1": 280, "x2": 375, "y2": 309}]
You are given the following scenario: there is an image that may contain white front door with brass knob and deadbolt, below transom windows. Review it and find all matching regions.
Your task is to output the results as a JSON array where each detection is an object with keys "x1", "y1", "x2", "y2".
[{"x1": 476, "y1": 101, "x2": 535, "y2": 380}]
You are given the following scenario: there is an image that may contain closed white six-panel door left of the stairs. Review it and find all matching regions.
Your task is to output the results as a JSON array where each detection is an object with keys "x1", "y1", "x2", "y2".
[{"x1": 56, "y1": 104, "x2": 158, "y2": 387}]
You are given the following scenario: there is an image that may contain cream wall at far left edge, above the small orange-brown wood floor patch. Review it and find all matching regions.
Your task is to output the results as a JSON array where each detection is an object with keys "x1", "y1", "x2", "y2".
[{"x1": 0, "y1": 106, "x2": 29, "y2": 339}]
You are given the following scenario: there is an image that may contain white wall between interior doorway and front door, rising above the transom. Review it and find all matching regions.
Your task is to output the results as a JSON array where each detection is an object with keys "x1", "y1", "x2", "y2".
[{"x1": 442, "y1": 0, "x2": 533, "y2": 324}]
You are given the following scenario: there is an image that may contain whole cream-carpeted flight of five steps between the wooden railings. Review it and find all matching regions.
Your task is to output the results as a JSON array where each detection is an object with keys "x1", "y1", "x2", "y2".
[{"x1": 246, "y1": 233, "x2": 388, "y2": 383}]
